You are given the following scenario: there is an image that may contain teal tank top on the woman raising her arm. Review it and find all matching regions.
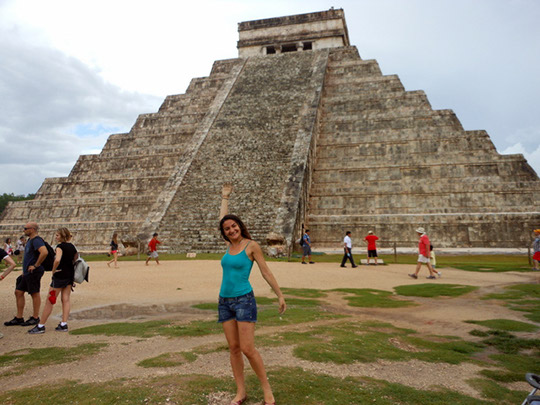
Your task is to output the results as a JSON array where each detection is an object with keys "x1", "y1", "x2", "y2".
[{"x1": 219, "y1": 242, "x2": 253, "y2": 298}]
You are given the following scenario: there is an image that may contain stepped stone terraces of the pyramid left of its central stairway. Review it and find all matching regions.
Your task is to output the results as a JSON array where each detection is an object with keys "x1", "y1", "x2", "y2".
[{"x1": 0, "y1": 61, "x2": 240, "y2": 251}]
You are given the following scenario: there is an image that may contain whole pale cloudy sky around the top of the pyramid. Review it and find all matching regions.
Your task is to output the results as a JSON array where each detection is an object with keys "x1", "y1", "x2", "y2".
[{"x1": 0, "y1": 0, "x2": 540, "y2": 194}]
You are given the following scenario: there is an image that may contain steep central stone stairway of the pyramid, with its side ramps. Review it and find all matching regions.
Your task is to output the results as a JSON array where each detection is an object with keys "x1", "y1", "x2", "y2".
[{"x1": 153, "y1": 51, "x2": 328, "y2": 251}]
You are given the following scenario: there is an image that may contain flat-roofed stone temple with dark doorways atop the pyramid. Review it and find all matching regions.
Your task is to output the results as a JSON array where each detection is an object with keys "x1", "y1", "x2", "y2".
[{"x1": 238, "y1": 8, "x2": 349, "y2": 58}]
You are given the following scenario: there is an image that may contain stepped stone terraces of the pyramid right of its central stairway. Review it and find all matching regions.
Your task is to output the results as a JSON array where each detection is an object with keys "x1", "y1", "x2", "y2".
[{"x1": 306, "y1": 48, "x2": 540, "y2": 249}]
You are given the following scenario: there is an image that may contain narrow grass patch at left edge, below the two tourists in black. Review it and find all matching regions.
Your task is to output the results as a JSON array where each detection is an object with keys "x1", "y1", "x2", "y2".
[{"x1": 0, "y1": 343, "x2": 107, "y2": 376}]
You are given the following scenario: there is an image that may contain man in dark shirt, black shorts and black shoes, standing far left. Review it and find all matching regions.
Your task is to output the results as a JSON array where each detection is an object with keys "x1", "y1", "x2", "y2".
[{"x1": 4, "y1": 222, "x2": 48, "y2": 326}]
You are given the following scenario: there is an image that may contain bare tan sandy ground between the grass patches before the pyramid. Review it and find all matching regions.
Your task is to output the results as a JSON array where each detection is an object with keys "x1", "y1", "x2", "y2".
[{"x1": 0, "y1": 260, "x2": 540, "y2": 398}]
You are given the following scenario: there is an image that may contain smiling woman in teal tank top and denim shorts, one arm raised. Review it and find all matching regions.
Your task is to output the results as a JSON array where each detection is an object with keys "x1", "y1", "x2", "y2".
[{"x1": 218, "y1": 184, "x2": 287, "y2": 405}]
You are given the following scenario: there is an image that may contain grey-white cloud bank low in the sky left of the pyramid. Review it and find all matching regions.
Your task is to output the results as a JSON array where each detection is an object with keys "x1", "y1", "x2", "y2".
[{"x1": 0, "y1": 22, "x2": 162, "y2": 194}]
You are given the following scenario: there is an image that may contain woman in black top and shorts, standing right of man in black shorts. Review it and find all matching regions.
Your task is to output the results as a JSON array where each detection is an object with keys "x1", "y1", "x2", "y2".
[{"x1": 28, "y1": 228, "x2": 78, "y2": 335}]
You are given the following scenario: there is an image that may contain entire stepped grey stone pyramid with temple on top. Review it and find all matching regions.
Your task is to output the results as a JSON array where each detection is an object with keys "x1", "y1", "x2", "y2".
[{"x1": 0, "y1": 9, "x2": 540, "y2": 254}]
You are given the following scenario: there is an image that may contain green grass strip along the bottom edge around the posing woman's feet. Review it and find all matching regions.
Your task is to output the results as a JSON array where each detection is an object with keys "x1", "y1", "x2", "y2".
[{"x1": 0, "y1": 367, "x2": 527, "y2": 405}]
